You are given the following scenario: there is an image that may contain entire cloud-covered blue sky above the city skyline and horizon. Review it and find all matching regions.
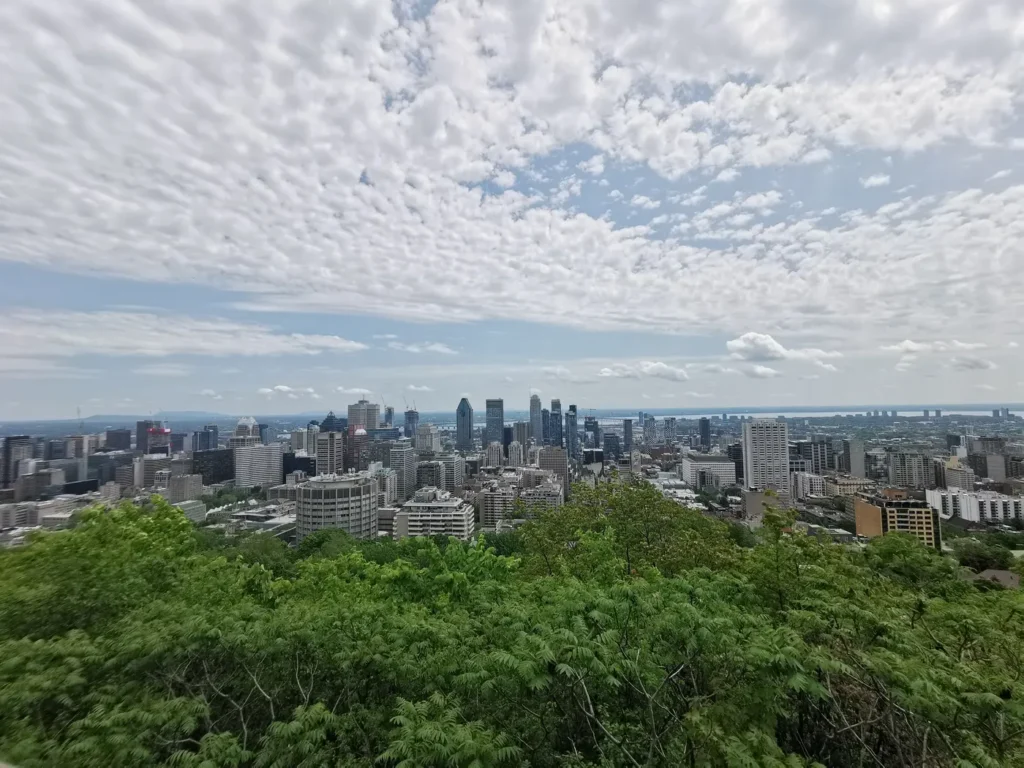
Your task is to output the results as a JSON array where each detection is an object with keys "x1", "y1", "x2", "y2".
[{"x1": 0, "y1": 0, "x2": 1024, "y2": 419}]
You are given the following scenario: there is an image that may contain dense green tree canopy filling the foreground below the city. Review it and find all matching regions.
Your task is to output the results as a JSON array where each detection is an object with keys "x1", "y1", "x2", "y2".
[{"x1": 0, "y1": 483, "x2": 1024, "y2": 768}]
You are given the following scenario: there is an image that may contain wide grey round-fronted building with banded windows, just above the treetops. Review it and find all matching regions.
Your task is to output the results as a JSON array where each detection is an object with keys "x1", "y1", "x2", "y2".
[{"x1": 295, "y1": 472, "x2": 377, "y2": 542}]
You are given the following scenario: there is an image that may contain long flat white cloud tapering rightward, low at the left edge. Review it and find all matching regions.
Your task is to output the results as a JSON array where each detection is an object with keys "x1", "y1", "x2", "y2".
[{"x1": 0, "y1": 309, "x2": 366, "y2": 357}]
